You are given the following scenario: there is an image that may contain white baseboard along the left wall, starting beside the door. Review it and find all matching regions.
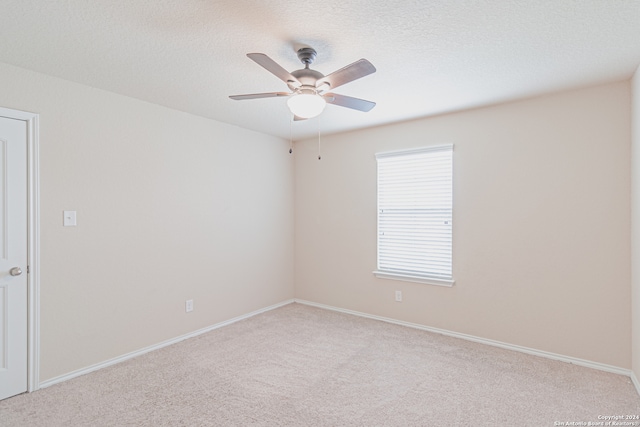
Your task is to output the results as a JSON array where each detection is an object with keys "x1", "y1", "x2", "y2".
[{"x1": 39, "y1": 299, "x2": 294, "y2": 388}]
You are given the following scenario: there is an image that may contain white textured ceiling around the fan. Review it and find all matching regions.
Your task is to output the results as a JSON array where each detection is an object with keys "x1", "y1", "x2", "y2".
[{"x1": 0, "y1": 0, "x2": 640, "y2": 138}]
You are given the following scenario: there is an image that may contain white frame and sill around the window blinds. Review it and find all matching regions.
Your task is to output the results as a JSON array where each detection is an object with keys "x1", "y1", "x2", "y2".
[{"x1": 373, "y1": 144, "x2": 455, "y2": 287}]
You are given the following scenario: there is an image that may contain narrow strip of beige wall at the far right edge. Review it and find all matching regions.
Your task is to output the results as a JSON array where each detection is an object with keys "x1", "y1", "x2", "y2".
[{"x1": 631, "y1": 68, "x2": 640, "y2": 378}]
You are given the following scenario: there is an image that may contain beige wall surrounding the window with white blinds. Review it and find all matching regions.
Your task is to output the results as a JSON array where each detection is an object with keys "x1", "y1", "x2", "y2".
[{"x1": 295, "y1": 82, "x2": 631, "y2": 368}]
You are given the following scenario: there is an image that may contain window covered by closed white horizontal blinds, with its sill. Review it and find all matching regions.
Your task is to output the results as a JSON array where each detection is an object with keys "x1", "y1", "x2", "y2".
[{"x1": 374, "y1": 145, "x2": 454, "y2": 286}]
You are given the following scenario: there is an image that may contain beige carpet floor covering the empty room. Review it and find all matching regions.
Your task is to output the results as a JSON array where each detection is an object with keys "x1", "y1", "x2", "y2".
[{"x1": 0, "y1": 304, "x2": 640, "y2": 427}]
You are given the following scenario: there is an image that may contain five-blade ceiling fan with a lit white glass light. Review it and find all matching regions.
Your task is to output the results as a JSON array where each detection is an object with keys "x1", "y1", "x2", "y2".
[{"x1": 229, "y1": 47, "x2": 376, "y2": 120}]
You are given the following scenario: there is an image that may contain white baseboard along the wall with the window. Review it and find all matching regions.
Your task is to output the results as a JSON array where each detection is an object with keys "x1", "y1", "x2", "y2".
[{"x1": 294, "y1": 299, "x2": 640, "y2": 380}]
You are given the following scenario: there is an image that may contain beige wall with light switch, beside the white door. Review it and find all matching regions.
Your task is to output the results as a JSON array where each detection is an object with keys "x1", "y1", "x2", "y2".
[{"x1": 0, "y1": 64, "x2": 293, "y2": 381}]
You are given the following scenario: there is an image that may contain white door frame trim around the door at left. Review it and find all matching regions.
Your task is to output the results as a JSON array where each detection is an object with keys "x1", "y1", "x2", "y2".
[{"x1": 0, "y1": 107, "x2": 40, "y2": 392}]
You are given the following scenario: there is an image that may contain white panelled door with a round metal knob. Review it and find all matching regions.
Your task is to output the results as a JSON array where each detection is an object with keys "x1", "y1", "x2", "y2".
[{"x1": 0, "y1": 117, "x2": 28, "y2": 399}]
